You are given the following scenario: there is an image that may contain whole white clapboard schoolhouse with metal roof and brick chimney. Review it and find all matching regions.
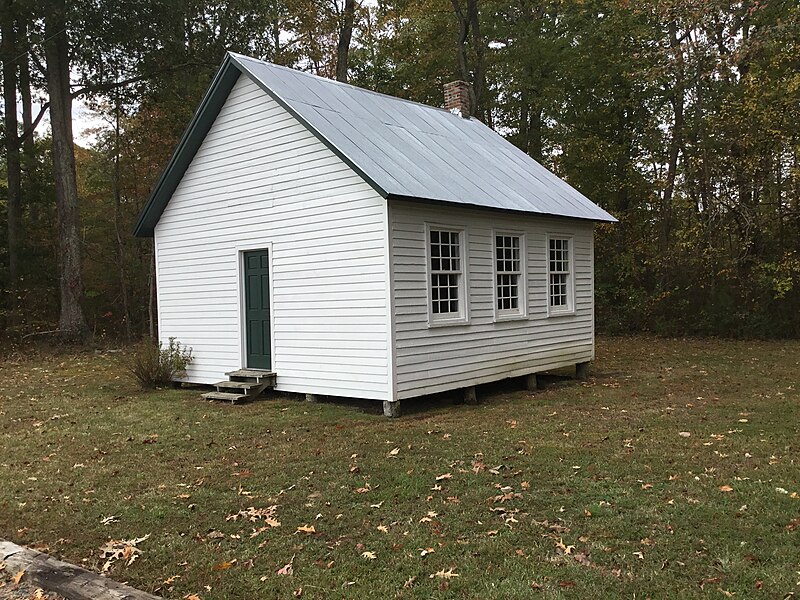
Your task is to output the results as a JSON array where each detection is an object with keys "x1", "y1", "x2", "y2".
[{"x1": 136, "y1": 53, "x2": 614, "y2": 416}]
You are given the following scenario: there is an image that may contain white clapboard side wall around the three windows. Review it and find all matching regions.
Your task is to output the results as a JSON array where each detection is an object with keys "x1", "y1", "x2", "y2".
[{"x1": 389, "y1": 201, "x2": 594, "y2": 399}]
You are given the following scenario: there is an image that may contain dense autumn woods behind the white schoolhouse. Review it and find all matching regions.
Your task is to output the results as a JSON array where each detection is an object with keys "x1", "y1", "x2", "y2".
[{"x1": 0, "y1": 0, "x2": 800, "y2": 340}]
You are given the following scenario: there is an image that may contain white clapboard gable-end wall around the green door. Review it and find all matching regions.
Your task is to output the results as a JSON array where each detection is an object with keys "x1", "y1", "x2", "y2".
[{"x1": 155, "y1": 75, "x2": 391, "y2": 400}]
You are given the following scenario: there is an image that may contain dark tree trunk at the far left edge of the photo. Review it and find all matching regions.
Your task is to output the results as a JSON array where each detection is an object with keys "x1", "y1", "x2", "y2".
[{"x1": 0, "y1": 0, "x2": 22, "y2": 288}]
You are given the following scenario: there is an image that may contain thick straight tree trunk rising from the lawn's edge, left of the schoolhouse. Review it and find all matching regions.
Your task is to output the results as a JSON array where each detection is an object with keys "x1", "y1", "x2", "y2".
[{"x1": 45, "y1": 0, "x2": 88, "y2": 340}]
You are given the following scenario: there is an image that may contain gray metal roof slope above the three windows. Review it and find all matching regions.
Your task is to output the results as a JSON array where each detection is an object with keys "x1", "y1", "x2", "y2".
[{"x1": 230, "y1": 53, "x2": 616, "y2": 221}]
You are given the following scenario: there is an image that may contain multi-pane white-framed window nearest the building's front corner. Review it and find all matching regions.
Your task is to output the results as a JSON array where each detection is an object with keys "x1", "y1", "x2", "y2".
[{"x1": 428, "y1": 227, "x2": 467, "y2": 322}]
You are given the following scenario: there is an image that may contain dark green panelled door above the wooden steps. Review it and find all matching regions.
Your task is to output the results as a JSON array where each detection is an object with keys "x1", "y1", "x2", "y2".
[{"x1": 244, "y1": 250, "x2": 272, "y2": 369}]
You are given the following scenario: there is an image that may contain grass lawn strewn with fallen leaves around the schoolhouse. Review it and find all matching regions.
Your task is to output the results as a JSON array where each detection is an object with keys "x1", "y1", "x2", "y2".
[{"x1": 0, "y1": 337, "x2": 800, "y2": 599}]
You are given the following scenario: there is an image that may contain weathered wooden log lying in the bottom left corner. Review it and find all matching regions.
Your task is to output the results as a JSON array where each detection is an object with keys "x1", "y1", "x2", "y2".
[{"x1": 0, "y1": 540, "x2": 160, "y2": 600}]
